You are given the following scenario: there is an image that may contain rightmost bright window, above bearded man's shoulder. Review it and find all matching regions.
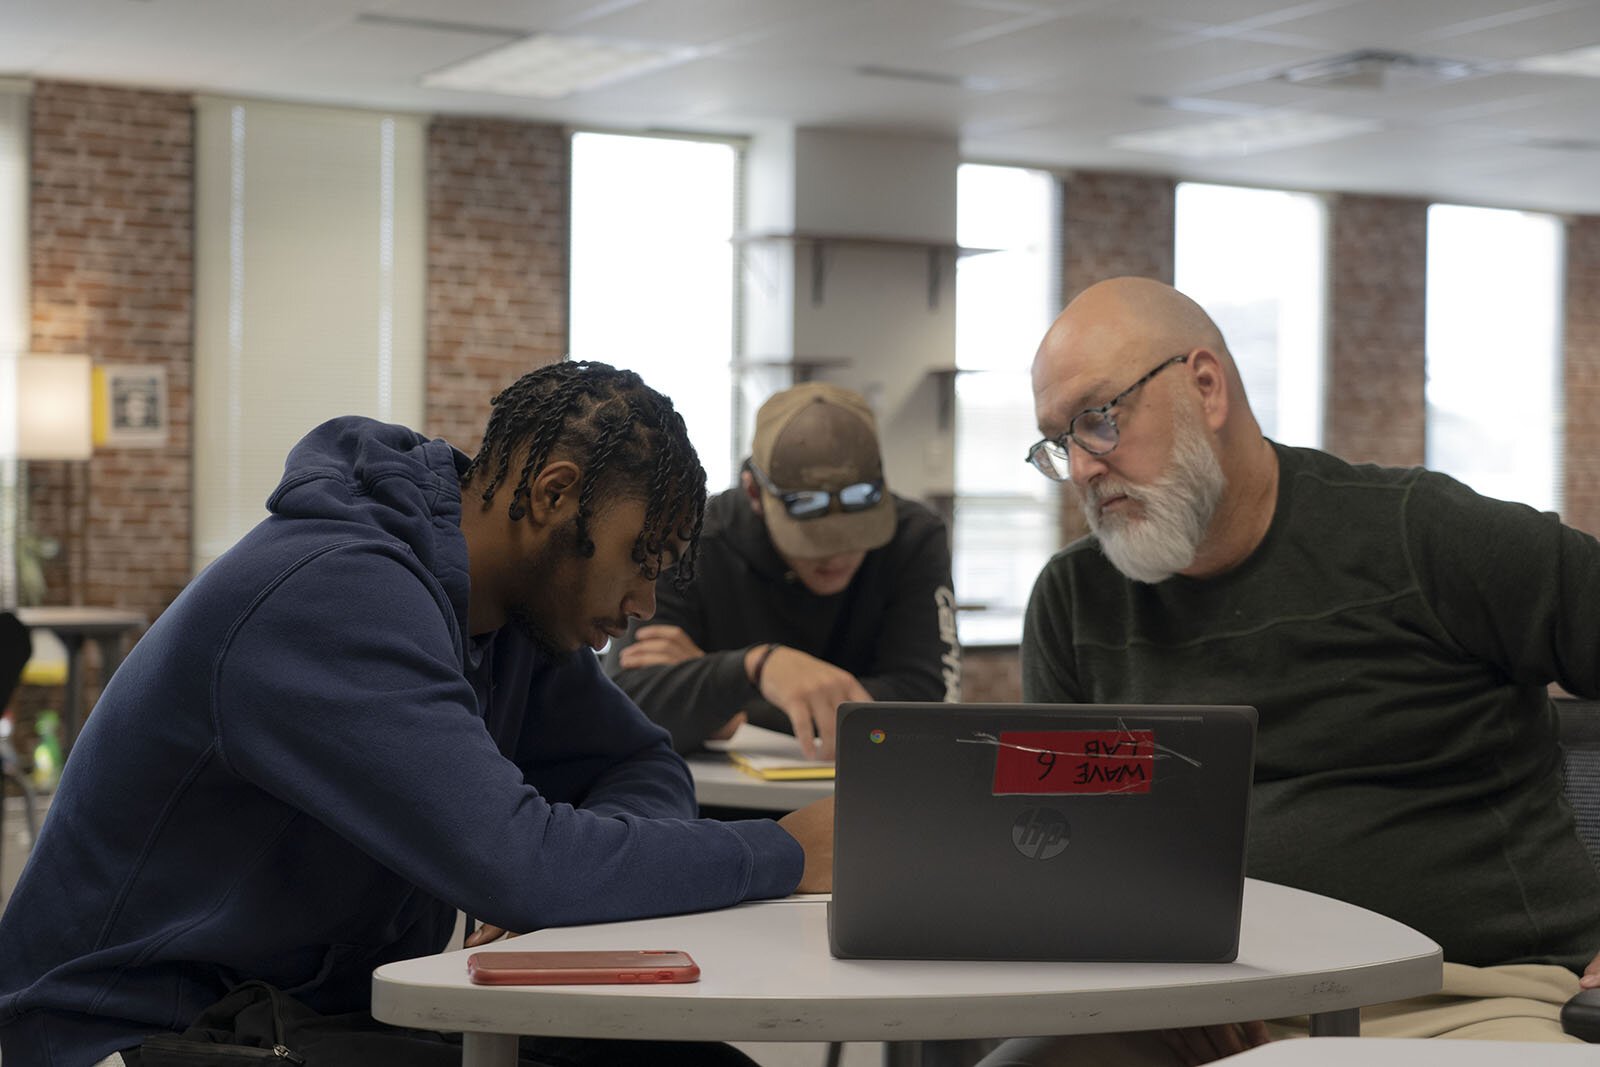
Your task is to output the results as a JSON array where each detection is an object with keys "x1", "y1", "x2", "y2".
[{"x1": 1427, "y1": 203, "x2": 1565, "y2": 510}]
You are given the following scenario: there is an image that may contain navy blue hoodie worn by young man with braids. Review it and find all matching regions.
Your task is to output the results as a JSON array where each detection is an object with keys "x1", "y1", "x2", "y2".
[{"x1": 0, "y1": 418, "x2": 803, "y2": 1067}]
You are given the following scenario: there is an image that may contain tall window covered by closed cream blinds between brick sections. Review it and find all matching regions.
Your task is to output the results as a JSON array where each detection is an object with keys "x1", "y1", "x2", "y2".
[{"x1": 194, "y1": 98, "x2": 426, "y2": 569}]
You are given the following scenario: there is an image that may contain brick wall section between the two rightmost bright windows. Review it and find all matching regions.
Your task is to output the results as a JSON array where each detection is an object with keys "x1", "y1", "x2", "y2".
[{"x1": 1323, "y1": 195, "x2": 1427, "y2": 467}]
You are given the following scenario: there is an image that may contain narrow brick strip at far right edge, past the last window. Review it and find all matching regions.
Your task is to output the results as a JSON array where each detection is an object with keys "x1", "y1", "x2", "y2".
[{"x1": 1562, "y1": 216, "x2": 1600, "y2": 534}]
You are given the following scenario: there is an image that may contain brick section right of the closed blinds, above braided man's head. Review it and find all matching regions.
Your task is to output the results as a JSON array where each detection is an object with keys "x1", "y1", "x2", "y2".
[{"x1": 426, "y1": 118, "x2": 570, "y2": 453}]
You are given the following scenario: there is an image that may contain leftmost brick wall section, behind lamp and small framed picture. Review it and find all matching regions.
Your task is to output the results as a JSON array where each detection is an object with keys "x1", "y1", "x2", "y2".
[{"x1": 29, "y1": 82, "x2": 194, "y2": 617}]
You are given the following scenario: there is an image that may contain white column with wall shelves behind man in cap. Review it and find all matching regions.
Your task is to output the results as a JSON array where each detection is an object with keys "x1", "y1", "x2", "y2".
[{"x1": 732, "y1": 128, "x2": 960, "y2": 498}]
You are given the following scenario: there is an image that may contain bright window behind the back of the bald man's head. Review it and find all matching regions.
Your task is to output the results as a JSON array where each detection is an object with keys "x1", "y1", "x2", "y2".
[{"x1": 1174, "y1": 182, "x2": 1328, "y2": 448}]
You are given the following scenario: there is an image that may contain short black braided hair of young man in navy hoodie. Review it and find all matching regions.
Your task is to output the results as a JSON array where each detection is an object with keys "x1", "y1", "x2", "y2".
[{"x1": 461, "y1": 360, "x2": 706, "y2": 589}]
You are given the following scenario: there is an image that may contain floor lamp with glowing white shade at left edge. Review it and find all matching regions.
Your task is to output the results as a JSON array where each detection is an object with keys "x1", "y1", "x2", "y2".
[{"x1": 0, "y1": 355, "x2": 94, "y2": 608}]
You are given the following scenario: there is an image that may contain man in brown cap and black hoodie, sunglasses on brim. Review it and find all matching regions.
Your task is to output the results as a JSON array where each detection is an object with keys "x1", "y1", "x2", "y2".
[{"x1": 606, "y1": 382, "x2": 962, "y2": 758}]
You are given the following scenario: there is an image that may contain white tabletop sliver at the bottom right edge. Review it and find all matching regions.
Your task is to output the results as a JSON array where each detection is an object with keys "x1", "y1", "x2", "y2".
[{"x1": 1218, "y1": 1037, "x2": 1600, "y2": 1067}]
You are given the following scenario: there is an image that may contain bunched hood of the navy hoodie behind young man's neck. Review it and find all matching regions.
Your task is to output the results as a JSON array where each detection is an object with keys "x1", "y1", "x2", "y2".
[{"x1": 267, "y1": 416, "x2": 470, "y2": 633}]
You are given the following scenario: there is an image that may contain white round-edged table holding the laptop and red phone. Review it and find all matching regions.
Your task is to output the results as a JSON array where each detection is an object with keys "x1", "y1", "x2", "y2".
[{"x1": 373, "y1": 880, "x2": 1443, "y2": 1067}]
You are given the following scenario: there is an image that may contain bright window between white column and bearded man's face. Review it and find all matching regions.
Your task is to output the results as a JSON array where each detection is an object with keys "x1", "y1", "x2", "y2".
[{"x1": 952, "y1": 163, "x2": 1061, "y2": 645}]
